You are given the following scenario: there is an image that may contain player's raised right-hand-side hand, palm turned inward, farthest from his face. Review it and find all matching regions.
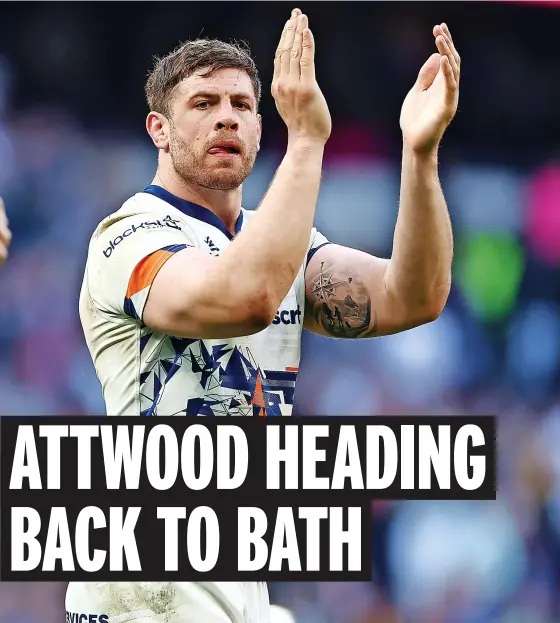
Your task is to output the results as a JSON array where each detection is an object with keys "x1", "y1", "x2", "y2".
[{"x1": 400, "y1": 24, "x2": 461, "y2": 153}]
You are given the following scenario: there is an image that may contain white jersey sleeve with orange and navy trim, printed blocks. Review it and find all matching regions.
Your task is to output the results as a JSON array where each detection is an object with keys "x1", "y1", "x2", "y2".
[{"x1": 87, "y1": 213, "x2": 195, "y2": 321}]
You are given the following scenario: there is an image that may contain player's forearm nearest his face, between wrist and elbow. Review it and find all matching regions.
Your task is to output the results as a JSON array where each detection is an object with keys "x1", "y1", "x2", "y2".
[{"x1": 219, "y1": 141, "x2": 324, "y2": 306}]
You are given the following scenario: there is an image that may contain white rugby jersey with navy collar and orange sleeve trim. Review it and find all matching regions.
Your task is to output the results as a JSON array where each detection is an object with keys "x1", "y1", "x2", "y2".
[{"x1": 80, "y1": 185, "x2": 328, "y2": 416}]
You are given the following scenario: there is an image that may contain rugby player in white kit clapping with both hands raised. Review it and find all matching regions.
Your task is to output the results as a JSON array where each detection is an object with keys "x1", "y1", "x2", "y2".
[{"x1": 71, "y1": 9, "x2": 460, "y2": 623}]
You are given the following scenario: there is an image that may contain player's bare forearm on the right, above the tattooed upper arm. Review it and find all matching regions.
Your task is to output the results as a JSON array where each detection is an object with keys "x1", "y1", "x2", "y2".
[{"x1": 385, "y1": 144, "x2": 453, "y2": 323}]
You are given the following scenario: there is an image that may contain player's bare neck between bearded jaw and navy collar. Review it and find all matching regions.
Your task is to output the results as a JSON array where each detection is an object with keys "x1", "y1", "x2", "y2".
[{"x1": 152, "y1": 171, "x2": 241, "y2": 234}]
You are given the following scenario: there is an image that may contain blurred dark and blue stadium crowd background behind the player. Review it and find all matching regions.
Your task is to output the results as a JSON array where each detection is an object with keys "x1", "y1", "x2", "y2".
[{"x1": 0, "y1": 1, "x2": 560, "y2": 623}]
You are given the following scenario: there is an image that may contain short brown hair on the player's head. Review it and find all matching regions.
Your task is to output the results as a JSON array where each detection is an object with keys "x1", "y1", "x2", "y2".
[{"x1": 145, "y1": 39, "x2": 261, "y2": 115}]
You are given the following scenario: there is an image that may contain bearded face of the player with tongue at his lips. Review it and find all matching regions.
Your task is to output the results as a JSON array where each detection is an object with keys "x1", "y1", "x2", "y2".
[{"x1": 169, "y1": 69, "x2": 261, "y2": 190}]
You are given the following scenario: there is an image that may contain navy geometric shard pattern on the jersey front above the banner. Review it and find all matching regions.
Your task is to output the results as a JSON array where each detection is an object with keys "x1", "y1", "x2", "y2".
[{"x1": 140, "y1": 332, "x2": 297, "y2": 417}]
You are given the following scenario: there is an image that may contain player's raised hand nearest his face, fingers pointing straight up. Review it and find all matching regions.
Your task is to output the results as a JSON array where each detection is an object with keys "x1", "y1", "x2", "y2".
[{"x1": 271, "y1": 9, "x2": 332, "y2": 146}]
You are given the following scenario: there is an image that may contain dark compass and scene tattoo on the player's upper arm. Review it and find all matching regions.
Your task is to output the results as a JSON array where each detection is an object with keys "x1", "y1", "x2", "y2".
[{"x1": 308, "y1": 262, "x2": 377, "y2": 339}]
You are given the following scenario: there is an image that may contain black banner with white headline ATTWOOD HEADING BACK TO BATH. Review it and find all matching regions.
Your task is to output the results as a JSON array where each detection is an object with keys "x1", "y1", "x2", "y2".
[{"x1": 0, "y1": 416, "x2": 496, "y2": 581}]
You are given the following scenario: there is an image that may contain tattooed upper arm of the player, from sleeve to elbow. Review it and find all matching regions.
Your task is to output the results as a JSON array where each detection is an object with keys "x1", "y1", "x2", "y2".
[{"x1": 304, "y1": 244, "x2": 396, "y2": 339}]
